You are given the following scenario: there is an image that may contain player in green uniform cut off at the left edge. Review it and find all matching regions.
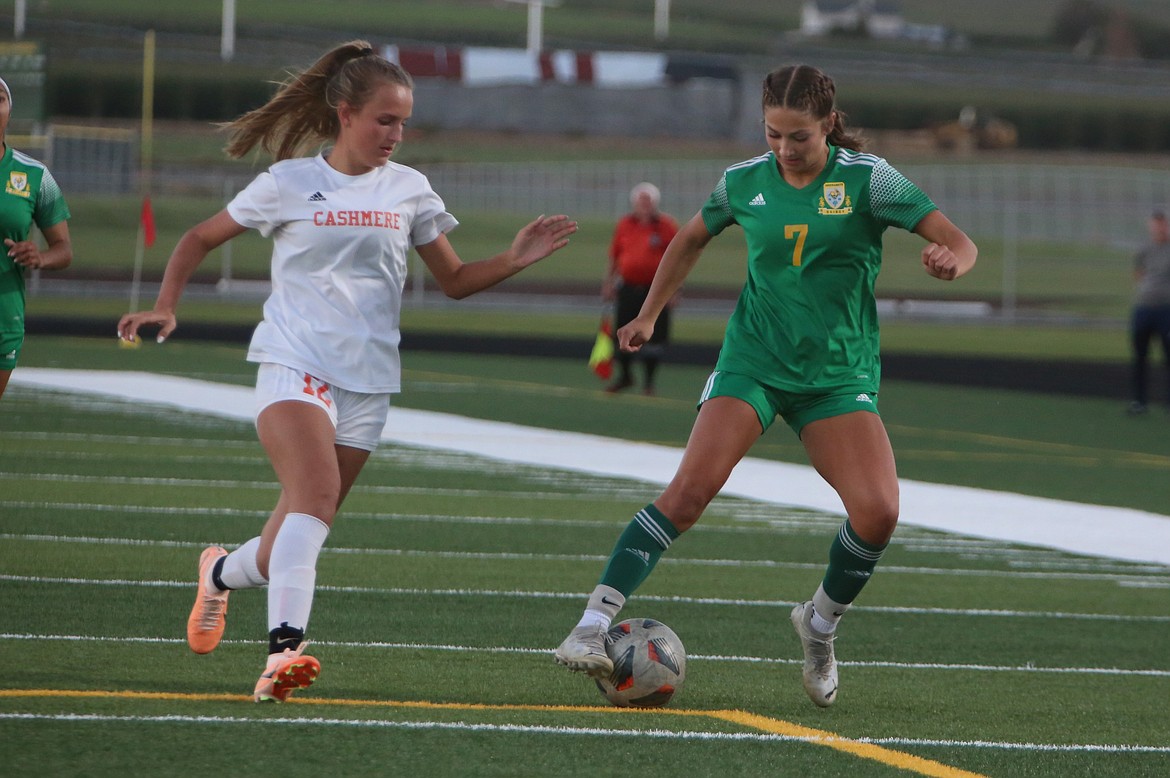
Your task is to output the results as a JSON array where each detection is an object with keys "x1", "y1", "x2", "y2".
[{"x1": 0, "y1": 78, "x2": 73, "y2": 397}]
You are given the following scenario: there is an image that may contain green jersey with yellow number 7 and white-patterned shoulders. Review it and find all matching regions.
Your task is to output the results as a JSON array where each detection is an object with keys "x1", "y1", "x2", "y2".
[{"x1": 702, "y1": 146, "x2": 935, "y2": 393}]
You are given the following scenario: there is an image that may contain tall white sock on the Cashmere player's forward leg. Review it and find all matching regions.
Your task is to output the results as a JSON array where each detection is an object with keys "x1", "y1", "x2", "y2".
[{"x1": 268, "y1": 514, "x2": 329, "y2": 632}]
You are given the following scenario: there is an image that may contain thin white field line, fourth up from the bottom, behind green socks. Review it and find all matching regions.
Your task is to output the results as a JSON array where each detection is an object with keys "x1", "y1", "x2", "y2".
[{"x1": 0, "y1": 531, "x2": 1170, "y2": 584}]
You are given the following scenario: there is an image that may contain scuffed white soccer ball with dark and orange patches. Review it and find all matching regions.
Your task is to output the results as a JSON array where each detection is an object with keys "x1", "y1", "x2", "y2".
[{"x1": 596, "y1": 619, "x2": 687, "y2": 708}]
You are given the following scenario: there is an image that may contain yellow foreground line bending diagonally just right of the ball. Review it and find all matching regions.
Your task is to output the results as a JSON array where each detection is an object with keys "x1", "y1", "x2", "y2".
[{"x1": 0, "y1": 689, "x2": 982, "y2": 778}]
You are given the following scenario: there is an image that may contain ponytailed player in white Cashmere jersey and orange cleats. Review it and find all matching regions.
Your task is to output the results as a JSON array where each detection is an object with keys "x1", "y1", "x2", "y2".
[{"x1": 118, "y1": 41, "x2": 577, "y2": 702}]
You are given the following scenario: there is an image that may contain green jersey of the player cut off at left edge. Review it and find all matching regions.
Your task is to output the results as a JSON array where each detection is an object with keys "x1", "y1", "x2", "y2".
[{"x1": 0, "y1": 146, "x2": 69, "y2": 334}]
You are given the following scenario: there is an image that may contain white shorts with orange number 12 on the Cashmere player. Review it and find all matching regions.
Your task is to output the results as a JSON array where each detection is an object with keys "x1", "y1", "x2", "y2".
[{"x1": 256, "y1": 362, "x2": 390, "y2": 452}]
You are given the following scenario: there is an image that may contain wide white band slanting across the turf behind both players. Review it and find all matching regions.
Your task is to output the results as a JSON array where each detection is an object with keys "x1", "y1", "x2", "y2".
[{"x1": 12, "y1": 367, "x2": 1170, "y2": 565}]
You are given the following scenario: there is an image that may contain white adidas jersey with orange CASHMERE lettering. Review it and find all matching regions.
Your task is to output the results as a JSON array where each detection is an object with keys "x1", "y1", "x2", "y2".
[{"x1": 227, "y1": 154, "x2": 459, "y2": 393}]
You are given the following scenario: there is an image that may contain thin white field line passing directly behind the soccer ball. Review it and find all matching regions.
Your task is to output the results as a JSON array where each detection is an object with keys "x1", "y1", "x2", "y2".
[{"x1": 0, "y1": 633, "x2": 1170, "y2": 679}]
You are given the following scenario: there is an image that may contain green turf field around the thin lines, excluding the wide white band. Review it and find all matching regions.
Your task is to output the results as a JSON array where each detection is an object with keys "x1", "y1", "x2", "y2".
[{"x1": 0, "y1": 338, "x2": 1170, "y2": 777}]
